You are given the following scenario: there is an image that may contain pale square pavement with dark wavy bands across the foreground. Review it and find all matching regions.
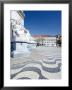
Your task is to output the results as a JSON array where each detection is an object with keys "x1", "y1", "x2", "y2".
[{"x1": 10, "y1": 46, "x2": 61, "y2": 80}]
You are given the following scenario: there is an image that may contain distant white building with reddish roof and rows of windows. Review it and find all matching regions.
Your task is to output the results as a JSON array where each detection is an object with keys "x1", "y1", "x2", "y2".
[{"x1": 33, "y1": 35, "x2": 56, "y2": 46}]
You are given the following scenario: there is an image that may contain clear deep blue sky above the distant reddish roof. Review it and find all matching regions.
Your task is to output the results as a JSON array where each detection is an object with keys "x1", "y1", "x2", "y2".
[{"x1": 24, "y1": 11, "x2": 61, "y2": 35}]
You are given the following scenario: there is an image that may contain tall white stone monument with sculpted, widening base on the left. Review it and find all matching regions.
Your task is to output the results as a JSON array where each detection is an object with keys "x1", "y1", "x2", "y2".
[{"x1": 10, "y1": 10, "x2": 36, "y2": 57}]
